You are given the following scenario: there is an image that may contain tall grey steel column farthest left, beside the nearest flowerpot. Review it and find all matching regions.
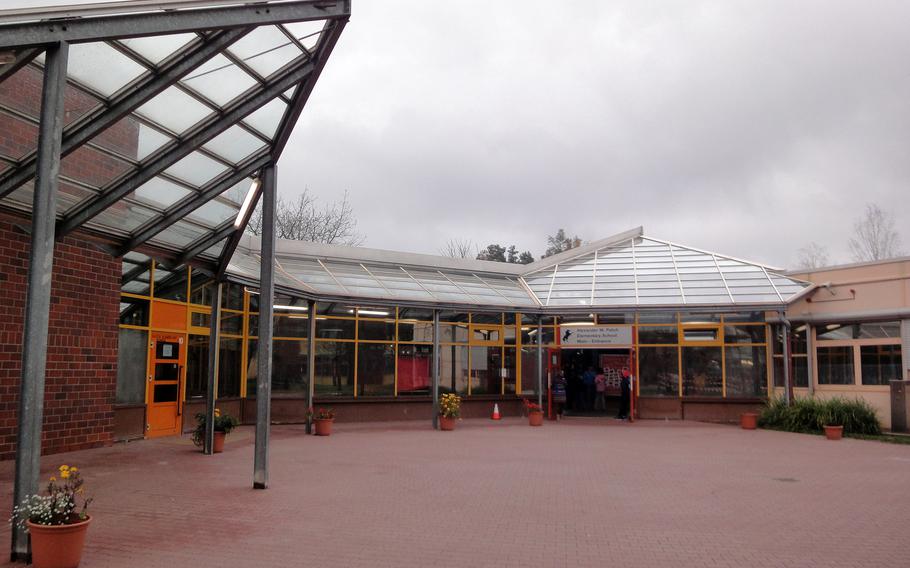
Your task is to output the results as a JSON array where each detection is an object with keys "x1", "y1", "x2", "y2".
[{"x1": 11, "y1": 43, "x2": 69, "y2": 560}]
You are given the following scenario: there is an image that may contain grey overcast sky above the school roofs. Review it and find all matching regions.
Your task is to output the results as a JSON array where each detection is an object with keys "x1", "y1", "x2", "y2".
[{"x1": 4, "y1": 0, "x2": 910, "y2": 266}]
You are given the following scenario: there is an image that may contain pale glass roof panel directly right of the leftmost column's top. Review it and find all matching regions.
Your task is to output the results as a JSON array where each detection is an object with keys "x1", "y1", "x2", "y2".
[{"x1": 67, "y1": 41, "x2": 147, "y2": 97}]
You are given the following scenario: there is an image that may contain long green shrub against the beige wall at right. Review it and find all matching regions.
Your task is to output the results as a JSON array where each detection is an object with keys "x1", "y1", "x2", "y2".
[{"x1": 758, "y1": 397, "x2": 882, "y2": 435}]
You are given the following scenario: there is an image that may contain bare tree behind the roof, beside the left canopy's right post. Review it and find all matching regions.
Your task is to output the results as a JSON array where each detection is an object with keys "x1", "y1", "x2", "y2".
[{"x1": 247, "y1": 189, "x2": 364, "y2": 246}]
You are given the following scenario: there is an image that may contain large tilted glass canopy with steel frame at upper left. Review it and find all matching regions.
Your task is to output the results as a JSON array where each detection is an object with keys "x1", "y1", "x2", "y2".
[{"x1": 0, "y1": 0, "x2": 350, "y2": 267}]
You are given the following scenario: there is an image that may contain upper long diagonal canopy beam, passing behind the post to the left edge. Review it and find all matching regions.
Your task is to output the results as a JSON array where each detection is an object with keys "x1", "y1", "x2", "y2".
[{"x1": 0, "y1": 27, "x2": 252, "y2": 202}]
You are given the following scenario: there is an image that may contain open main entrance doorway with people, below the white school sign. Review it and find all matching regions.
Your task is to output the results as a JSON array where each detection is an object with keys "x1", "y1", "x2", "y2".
[{"x1": 561, "y1": 349, "x2": 634, "y2": 416}]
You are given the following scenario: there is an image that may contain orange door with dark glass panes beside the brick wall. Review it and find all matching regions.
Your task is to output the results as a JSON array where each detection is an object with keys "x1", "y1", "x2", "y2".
[{"x1": 146, "y1": 332, "x2": 186, "y2": 438}]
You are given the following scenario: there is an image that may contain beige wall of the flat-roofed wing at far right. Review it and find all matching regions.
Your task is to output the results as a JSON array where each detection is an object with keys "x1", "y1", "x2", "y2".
[{"x1": 775, "y1": 258, "x2": 910, "y2": 428}]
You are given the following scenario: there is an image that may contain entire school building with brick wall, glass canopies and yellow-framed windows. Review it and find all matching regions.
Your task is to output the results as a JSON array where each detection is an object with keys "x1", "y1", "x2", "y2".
[{"x1": 0, "y1": 0, "x2": 910, "y2": 555}]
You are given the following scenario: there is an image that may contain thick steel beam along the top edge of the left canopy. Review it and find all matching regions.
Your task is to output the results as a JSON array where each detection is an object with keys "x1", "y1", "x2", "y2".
[{"x1": 0, "y1": 0, "x2": 351, "y2": 49}]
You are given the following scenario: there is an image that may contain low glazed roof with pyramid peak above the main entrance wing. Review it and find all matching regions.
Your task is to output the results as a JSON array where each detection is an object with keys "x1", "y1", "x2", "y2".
[{"x1": 227, "y1": 232, "x2": 809, "y2": 311}]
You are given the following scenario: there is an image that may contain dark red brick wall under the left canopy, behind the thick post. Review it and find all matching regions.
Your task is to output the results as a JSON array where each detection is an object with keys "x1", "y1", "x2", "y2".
[{"x1": 0, "y1": 217, "x2": 120, "y2": 460}]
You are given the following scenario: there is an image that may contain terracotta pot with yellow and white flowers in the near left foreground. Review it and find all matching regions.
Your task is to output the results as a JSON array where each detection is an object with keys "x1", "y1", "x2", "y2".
[{"x1": 10, "y1": 465, "x2": 92, "y2": 568}]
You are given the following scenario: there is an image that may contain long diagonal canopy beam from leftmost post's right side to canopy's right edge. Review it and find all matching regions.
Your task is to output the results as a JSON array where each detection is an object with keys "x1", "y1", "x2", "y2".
[{"x1": 57, "y1": 56, "x2": 313, "y2": 238}]
